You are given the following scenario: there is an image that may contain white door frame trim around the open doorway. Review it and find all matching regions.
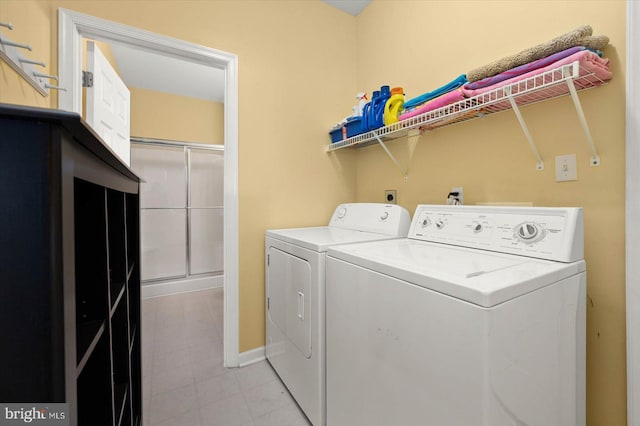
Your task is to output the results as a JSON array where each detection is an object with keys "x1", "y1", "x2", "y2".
[{"x1": 58, "y1": 9, "x2": 239, "y2": 367}]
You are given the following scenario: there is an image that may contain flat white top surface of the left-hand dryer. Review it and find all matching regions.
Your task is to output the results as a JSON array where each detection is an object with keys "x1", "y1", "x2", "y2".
[{"x1": 267, "y1": 226, "x2": 396, "y2": 252}]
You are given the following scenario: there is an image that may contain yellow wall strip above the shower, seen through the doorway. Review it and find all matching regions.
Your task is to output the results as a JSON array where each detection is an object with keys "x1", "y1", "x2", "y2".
[{"x1": 130, "y1": 87, "x2": 224, "y2": 145}]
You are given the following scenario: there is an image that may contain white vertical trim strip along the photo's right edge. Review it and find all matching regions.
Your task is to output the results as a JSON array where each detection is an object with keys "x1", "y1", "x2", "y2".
[{"x1": 626, "y1": 1, "x2": 640, "y2": 426}]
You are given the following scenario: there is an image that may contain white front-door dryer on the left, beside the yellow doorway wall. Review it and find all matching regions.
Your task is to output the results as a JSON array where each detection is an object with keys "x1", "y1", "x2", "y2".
[{"x1": 265, "y1": 203, "x2": 411, "y2": 426}]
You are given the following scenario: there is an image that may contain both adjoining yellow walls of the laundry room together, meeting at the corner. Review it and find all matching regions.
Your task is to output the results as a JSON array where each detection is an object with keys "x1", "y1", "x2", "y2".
[{"x1": 0, "y1": 0, "x2": 626, "y2": 426}]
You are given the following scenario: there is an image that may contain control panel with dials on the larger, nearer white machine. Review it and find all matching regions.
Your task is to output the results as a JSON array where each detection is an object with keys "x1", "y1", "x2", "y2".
[{"x1": 409, "y1": 205, "x2": 584, "y2": 262}]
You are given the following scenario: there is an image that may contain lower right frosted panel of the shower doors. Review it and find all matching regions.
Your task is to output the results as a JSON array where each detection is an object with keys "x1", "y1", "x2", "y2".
[{"x1": 189, "y1": 208, "x2": 224, "y2": 274}]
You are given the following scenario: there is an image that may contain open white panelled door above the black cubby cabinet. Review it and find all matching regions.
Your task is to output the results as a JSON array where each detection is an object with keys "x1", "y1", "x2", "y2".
[{"x1": 86, "y1": 41, "x2": 131, "y2": 166}]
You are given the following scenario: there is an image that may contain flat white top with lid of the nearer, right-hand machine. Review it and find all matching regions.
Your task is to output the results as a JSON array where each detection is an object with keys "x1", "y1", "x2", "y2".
[{"x1": 328, "y1": 239, "x2": 585, "y2": 307}]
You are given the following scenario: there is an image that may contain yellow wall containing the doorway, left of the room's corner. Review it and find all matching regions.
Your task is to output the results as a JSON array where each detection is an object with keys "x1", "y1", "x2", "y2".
[{"x1": 0, "y1": 0, "x2": 357, "y2": 352}]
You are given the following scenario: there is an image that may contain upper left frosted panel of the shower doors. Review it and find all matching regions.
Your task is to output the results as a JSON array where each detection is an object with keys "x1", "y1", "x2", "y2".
[{"x1": 131, "y1": 144, "x2": 187, "y2": 209}]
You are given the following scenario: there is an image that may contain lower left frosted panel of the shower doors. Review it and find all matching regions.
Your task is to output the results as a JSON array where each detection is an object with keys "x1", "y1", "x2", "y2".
[{"x1": 140, "y1": 209, "x2": 187, "y2": 281}]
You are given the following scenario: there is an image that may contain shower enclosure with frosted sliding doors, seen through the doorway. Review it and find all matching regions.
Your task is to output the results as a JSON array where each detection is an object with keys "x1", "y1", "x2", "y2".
[{"x1": 131, "y1": 138, "x2": 224, "y2": 297}]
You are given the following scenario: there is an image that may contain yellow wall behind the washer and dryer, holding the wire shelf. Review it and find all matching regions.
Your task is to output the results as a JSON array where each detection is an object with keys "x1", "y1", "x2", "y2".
[{"x1": 350, "y1": 1, "x2": 626, "y2": 426}]
